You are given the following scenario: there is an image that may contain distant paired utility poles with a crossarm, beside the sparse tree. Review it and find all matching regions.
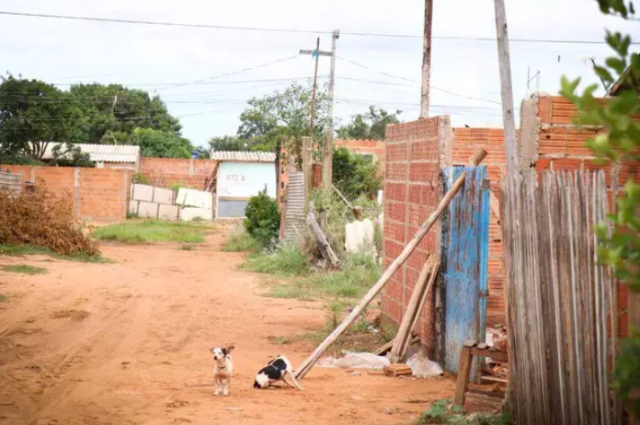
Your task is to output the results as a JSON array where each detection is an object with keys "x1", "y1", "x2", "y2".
[{"x1": 300, "y1": 30, "x2": 340, "y2": 189}]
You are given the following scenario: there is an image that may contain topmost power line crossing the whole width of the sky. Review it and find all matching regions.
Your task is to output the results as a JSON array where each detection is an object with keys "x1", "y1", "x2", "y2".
[{"x1": 0, "y1": 11, "x2": 640, "y2": 45}]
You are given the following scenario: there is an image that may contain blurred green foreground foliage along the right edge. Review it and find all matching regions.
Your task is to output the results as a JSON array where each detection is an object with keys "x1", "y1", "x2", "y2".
[{"x1": 561, "y1": 0, "x2": 640, "y2": 416}]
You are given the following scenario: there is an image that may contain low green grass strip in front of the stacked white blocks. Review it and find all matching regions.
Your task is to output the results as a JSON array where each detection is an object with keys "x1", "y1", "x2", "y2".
[{"x1": 93, "y1": 220, "x2": 210, "y2": 244}]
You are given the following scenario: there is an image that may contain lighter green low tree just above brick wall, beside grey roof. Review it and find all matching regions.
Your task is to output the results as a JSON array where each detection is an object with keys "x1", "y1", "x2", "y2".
[{"x1": 126, "y1": 128, "x2": 194, "y2": 158}]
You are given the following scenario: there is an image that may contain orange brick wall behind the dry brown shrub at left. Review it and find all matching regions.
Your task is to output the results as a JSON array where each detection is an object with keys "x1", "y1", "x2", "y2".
[{"x1": 1, "y1": 165, "x2": 133, "y2": 222}]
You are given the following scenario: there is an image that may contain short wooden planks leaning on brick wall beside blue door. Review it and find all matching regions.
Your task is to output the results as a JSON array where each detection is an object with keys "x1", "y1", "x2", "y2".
[{"x1": 389, "y1": 255, "x2": 440, "y2": 363}]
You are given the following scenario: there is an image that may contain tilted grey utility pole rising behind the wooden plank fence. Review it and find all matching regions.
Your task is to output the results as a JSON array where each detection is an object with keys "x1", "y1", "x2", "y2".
[{"x1": 494, "y1": 0, "x2": 521, "y2": 176}]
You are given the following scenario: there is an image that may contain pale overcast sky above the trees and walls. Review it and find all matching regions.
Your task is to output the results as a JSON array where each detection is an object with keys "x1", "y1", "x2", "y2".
[{"x1": 0, "y1": 0, "x2": 640, "y2": 145}]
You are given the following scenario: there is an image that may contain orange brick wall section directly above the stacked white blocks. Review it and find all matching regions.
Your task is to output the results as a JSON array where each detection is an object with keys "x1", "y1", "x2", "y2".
[{"x1": 140, "y1": 158, "x2": 218, "y2": 190}]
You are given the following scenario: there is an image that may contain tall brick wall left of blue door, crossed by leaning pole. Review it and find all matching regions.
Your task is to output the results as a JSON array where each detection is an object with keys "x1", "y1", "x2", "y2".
[{"x1": 381, "y1": 117, "x2": 450, "y2": 348}]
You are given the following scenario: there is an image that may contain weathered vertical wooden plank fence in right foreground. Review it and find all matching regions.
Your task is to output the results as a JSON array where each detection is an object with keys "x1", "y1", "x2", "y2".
[{"x1": 501, "y1": 171, "x2": 622, "y2": 425}]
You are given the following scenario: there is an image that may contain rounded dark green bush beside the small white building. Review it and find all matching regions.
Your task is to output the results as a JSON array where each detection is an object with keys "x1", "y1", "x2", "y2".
[{"x1": 244, "y1": 191, "x2": 280, "y2": 245}]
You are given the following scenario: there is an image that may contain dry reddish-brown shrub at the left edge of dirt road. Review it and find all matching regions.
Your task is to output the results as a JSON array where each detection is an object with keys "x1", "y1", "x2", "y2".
[{"x1": 0, "y1": 180, "x2": 99, "y2": 255}]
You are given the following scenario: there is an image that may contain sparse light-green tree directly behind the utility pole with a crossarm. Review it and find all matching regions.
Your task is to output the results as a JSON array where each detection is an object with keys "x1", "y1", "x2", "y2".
[{"x1": 238, "y1": 84, "x2": 329, "y2": 155}]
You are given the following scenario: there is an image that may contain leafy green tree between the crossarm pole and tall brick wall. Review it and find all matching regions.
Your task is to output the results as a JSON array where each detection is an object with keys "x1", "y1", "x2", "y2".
[{"x1": 333, "y1": 147, "x2": 382, "y2": 199}]
